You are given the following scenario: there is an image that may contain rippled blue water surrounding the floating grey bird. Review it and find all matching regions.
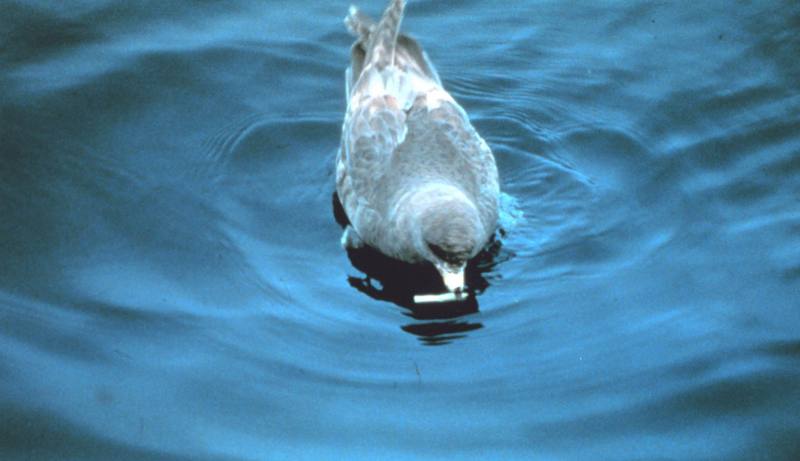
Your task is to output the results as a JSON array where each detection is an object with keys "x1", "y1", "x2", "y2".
[{"x1": 0, "y1": 0, "x2": 800, "y2": 461}]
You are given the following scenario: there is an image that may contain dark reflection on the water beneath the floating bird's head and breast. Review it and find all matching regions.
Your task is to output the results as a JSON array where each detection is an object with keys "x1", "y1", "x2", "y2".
[{"x1": 333, "y1": 193, "x2": 501, "y2": 345}]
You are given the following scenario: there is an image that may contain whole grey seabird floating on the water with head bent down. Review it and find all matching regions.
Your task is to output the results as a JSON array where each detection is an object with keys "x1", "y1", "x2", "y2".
[{"x1": 336, "y1": 0, "x2": 500, "y2": 296}]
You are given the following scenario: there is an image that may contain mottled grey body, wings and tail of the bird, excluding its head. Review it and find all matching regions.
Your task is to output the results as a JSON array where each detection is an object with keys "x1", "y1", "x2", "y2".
[{"x1": 337, "y1": 0, "x2": 499, "y2": 260}]
